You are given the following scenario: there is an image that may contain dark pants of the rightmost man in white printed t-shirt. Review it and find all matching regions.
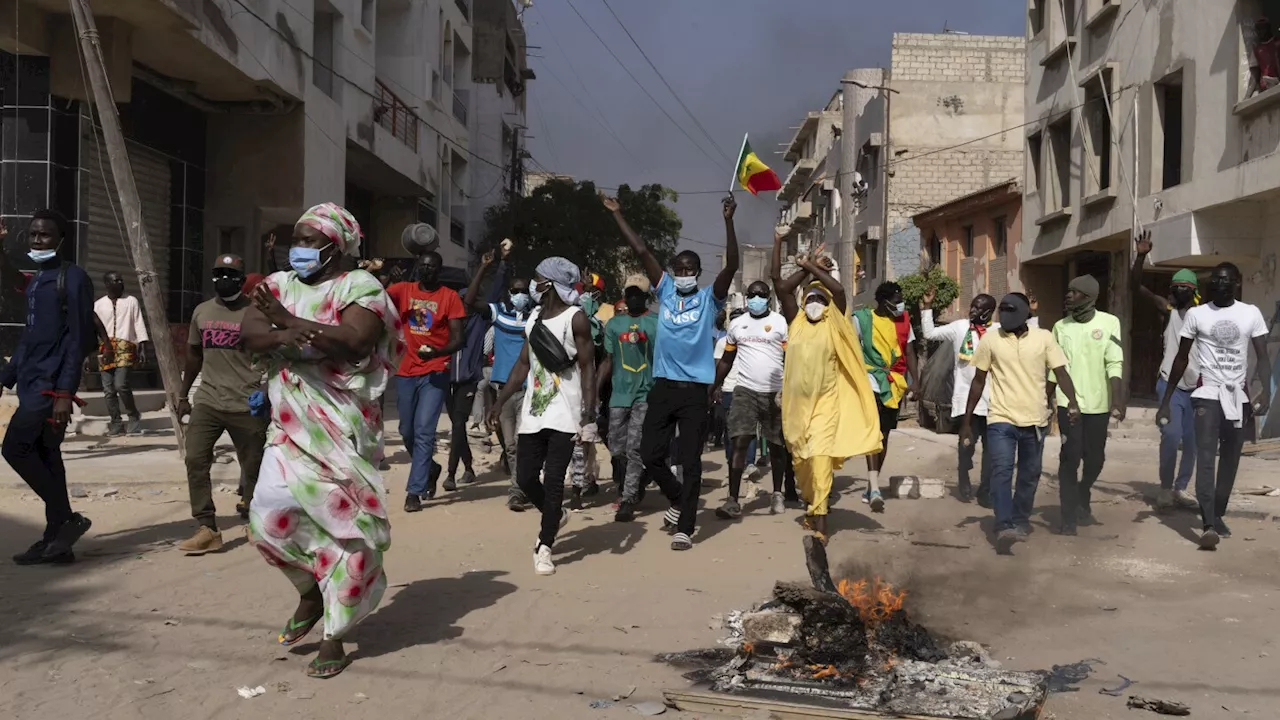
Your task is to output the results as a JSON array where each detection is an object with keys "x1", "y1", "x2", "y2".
[{"x1": 1192, "y1": 397, "x2": 1253, "y2": 528}]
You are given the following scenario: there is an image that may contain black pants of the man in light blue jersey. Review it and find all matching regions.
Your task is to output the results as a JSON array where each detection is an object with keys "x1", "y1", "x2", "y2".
[{"x1": 640, "y1": 378, "x2": 709, "y2": 534}]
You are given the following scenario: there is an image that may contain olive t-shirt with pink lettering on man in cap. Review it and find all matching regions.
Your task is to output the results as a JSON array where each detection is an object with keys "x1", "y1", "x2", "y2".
[{"x1": 187, "y1": 299, "x2": 262, "y2": 413}]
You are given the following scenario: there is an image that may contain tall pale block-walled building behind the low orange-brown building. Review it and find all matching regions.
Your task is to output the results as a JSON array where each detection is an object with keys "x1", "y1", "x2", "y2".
[{"x1": 837, "y1": 33, "x2": 1024, "y2": 305}]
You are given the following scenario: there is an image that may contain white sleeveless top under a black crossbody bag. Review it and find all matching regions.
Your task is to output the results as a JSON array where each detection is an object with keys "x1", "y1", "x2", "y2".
[{"x1": 520, "y1": 302, "x2": 582, "y2": 434}]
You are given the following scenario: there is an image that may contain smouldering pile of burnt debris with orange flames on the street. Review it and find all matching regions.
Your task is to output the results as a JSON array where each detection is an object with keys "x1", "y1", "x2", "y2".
[{"x1": 659, "y1": 537, "x2": 1047, "y2": 720}]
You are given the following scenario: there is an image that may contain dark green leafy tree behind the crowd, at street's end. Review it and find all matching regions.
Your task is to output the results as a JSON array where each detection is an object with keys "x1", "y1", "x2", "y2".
[{"x1": 480, "y1": 179, "x2": 682, "y2": 301}]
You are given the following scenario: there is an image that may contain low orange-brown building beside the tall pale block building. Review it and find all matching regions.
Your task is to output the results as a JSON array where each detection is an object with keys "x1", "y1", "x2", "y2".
[{"x1": 913, "y1": 179, "x2": 1023, "y2": 318}]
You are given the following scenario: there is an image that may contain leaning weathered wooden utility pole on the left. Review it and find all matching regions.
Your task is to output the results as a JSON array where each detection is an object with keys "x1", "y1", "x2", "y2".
[{"x1": 70, "y1": 0, "x2": 187, "y2": 459}]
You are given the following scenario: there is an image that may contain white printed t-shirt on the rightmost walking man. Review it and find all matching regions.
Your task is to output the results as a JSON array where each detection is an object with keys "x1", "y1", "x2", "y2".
[{"x1": 1181, "y1": 295, "x2": 1270, "y2": 405}]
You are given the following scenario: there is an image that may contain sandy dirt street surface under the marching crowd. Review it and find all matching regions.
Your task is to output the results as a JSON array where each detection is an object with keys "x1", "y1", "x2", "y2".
[{"x1": 0, "y1": 420, "x2": 1280, "y2": 720}]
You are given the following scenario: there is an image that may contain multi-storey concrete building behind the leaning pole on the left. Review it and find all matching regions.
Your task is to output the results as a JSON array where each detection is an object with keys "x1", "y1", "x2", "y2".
[{"x1": 0, "y1": 0, "x2": 472, "y2": 376}]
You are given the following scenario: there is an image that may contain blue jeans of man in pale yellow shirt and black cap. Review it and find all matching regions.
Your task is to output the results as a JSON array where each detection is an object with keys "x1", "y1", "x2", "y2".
[{"x1": 982, "y1": 423, "x2": 1044, "y2": 533}]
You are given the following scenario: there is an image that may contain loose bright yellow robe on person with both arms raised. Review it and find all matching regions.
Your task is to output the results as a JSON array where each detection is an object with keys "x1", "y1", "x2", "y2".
[{"x1": 782, "y1": 301, "x2": 881, "y2": 460}]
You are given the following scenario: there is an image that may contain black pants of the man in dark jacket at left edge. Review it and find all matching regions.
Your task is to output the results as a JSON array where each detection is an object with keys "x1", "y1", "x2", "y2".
[{"x1": 0, "y1": 395, "x2": 72, "y2": 542}]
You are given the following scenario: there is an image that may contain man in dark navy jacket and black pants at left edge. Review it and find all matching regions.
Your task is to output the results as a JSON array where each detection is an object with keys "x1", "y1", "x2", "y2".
[{"x1": 0, "y1": 210, "x2": 96, "y2": 565}]
